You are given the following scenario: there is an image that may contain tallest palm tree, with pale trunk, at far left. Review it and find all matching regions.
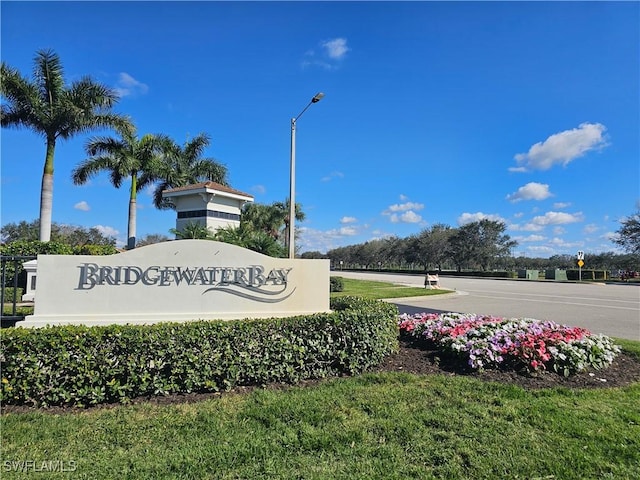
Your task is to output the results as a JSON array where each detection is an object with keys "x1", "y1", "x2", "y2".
[{"x1": 0, "y1": 50, "x2": 127, "y2": 242}]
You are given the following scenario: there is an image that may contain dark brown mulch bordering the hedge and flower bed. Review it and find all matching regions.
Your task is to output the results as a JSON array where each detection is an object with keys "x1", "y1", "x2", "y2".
[{"x1": 1, "y1": 337, "x2": 640, "y2": 414}]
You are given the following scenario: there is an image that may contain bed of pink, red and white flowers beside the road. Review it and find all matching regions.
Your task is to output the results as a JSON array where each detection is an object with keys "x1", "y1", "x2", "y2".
[{"x1": 398, "y1": 313, "x2": 620, "y2": 376}]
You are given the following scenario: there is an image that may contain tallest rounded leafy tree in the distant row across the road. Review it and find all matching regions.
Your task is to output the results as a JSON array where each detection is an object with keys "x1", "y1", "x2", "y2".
[{"x1": 451, "y1": 218, "x2": 518, "y2": 271}]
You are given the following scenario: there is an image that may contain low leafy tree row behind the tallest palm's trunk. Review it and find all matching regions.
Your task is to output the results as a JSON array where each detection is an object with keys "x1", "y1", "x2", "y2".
[{"x1": 0, "y1": 220, "x2": 116, "y2": 246}]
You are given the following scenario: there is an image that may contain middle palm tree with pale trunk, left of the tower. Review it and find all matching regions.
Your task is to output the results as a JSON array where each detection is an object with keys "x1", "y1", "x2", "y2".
[{"x1": 71, "y1": 125, "x2": 170, "y2": 250}]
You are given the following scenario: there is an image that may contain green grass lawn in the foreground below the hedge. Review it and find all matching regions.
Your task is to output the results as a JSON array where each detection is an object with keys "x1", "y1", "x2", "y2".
[{"x1": 0, "y1": 373, "x2": 640, "y2": 480}]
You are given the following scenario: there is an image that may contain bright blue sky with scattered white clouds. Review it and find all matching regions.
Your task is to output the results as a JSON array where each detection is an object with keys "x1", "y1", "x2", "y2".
[{"x1": 0, "y1": 1, "x2": 640, "y2": 257}]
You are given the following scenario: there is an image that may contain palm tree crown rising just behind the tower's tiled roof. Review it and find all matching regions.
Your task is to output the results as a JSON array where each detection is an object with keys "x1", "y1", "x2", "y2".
[{"x1": 153, "y1": 133, "x2": 228, "y2": 209}]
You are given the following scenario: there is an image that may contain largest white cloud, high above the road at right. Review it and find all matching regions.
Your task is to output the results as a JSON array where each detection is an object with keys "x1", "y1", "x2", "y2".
[{"x1": 509, "y1": 123, "x2": 607, "y2": 172}]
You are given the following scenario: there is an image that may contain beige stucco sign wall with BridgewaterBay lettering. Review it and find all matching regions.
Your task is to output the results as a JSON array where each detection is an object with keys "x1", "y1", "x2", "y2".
[{"x1": 18, "y1": 240, "x2": 329, "y2": 327}]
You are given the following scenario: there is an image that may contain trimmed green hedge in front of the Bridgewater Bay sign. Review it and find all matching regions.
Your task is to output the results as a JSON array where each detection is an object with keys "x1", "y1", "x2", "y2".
[{"x1": 0, "y1": 297, "x2": 398, "y2": 406}]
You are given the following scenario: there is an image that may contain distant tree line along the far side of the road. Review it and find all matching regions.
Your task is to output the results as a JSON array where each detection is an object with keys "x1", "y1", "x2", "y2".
[{"x1": 302, "y1": 214, "x2": 640, "y2": 271}]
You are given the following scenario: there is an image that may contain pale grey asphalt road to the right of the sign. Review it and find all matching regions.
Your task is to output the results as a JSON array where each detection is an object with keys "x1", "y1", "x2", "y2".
[{"x1": 331, "y1": 271, "x2": 640, "y2": 340}]
